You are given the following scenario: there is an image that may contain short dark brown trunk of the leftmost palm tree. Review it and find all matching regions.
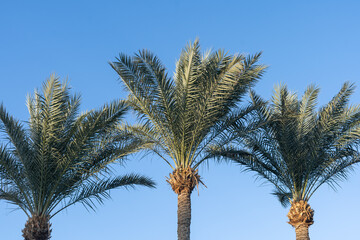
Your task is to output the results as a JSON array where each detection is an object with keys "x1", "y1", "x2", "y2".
[{"x1": 22, "y1": 215, "x2": 51, "y2": 240}]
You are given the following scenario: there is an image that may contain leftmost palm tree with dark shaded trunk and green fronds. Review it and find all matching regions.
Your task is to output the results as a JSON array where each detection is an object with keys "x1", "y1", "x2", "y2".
[{"x1": 0, "y1": 76, "x2": 154, "y2": 240}]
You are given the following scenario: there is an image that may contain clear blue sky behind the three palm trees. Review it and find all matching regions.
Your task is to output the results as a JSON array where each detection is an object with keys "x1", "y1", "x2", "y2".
[{"x1": 0, "y1": 0, "x2": 360, "y2": 240}]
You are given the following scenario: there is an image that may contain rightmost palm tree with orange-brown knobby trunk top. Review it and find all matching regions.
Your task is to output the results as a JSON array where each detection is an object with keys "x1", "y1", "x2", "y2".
[{"x1": 213, "y1": 83, "x2": 360, "y2": 240}]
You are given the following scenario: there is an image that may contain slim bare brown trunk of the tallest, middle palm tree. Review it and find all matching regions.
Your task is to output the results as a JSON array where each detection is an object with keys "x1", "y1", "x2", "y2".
[{"x1": 178, "y1": 191, "x2": 191, "y2": 240}]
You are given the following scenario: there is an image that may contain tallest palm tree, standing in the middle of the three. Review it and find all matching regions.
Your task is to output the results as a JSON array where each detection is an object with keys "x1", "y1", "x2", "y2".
[{"x1": 110, "y1": 40, "x2": 265, "y2": 240}]
